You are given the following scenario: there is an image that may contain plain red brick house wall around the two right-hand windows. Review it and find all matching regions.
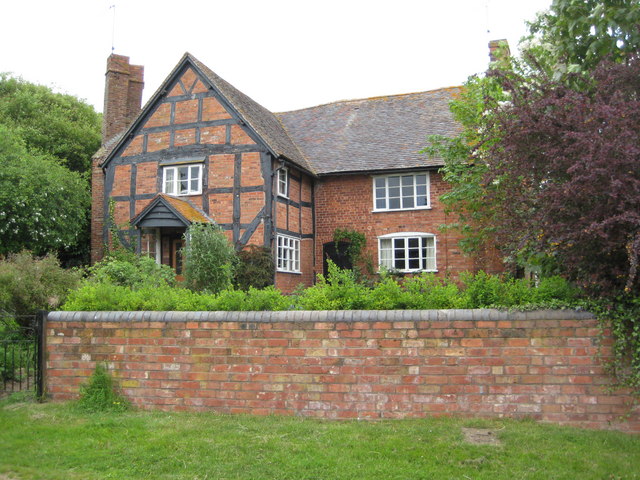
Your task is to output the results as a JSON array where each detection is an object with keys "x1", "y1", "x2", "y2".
[{"x1": 315, "y1": 172, "x2": 476, "y2": 275}]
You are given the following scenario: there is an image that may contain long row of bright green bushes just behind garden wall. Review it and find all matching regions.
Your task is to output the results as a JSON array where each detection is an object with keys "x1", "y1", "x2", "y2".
[{"x1": 63, "y1": 264, "x2": 578, "y2": 311}]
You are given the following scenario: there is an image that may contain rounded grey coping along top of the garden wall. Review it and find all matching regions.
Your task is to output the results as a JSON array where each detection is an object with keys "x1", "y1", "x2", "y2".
[{"x1": 48, "y1": 309, "x2": 595, "y2": 323}]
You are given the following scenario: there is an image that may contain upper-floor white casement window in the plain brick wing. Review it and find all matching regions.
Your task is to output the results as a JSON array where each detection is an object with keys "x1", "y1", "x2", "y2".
[{"x1": 373, "y1": 172, "x2": 431, "y2": 212}]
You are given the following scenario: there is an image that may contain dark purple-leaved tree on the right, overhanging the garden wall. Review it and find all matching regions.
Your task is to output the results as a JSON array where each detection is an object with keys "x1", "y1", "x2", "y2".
[{"x1": 482, "y1": 54, "x2": 640, "y2": 293}]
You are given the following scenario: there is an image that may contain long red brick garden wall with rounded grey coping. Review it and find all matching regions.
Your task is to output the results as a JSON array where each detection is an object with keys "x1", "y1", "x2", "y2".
[{"x1": 46, "y1": 310, "x2": 640, "y2": 432}]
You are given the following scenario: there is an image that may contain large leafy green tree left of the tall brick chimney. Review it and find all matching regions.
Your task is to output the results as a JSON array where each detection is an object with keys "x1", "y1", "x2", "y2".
[{"x1": 0, "y1": 74, "x2": 101, "y2": 264}]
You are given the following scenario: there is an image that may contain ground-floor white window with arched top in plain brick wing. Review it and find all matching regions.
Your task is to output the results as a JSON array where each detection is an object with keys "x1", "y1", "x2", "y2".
[{"x1": 378, "y1": 232, "x2": 437, "y2": 272}]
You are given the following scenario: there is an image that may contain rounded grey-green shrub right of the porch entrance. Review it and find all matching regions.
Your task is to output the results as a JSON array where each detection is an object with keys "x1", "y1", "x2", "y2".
[{"x1": 183, "y1": 223, "x2": 237, "y2": 293}]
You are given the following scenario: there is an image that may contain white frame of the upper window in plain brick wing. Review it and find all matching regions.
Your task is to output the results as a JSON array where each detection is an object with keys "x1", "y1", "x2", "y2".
[{"x1": 372, "y1": 171, "x2": 431, "y2": 212}]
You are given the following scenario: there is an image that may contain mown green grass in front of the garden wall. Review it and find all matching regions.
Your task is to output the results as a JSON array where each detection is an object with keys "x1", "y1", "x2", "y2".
[{"x1": 0, "y1": 400, "x2": 640, "y2": 480}]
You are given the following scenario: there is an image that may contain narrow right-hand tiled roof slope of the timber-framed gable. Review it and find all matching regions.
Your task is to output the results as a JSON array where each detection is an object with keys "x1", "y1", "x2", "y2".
[{"x1": 185, "y1": 53, "x2": 313, "y2": 172}]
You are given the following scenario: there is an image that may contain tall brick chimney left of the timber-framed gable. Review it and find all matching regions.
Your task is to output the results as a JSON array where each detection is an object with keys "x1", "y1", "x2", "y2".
[{"x1": 102, "y1": 53, "x2": 144, "y2": 144}]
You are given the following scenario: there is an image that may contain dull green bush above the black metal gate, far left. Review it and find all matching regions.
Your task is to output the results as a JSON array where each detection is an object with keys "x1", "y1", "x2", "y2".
[{"x1": 0, "y1": 252, "x2": 81, "y2": 319}]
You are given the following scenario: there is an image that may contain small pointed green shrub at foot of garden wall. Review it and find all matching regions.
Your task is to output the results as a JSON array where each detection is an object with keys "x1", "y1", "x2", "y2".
[{"x1": 78, "y1": 364, "x2": 129, "y2": 413}]
